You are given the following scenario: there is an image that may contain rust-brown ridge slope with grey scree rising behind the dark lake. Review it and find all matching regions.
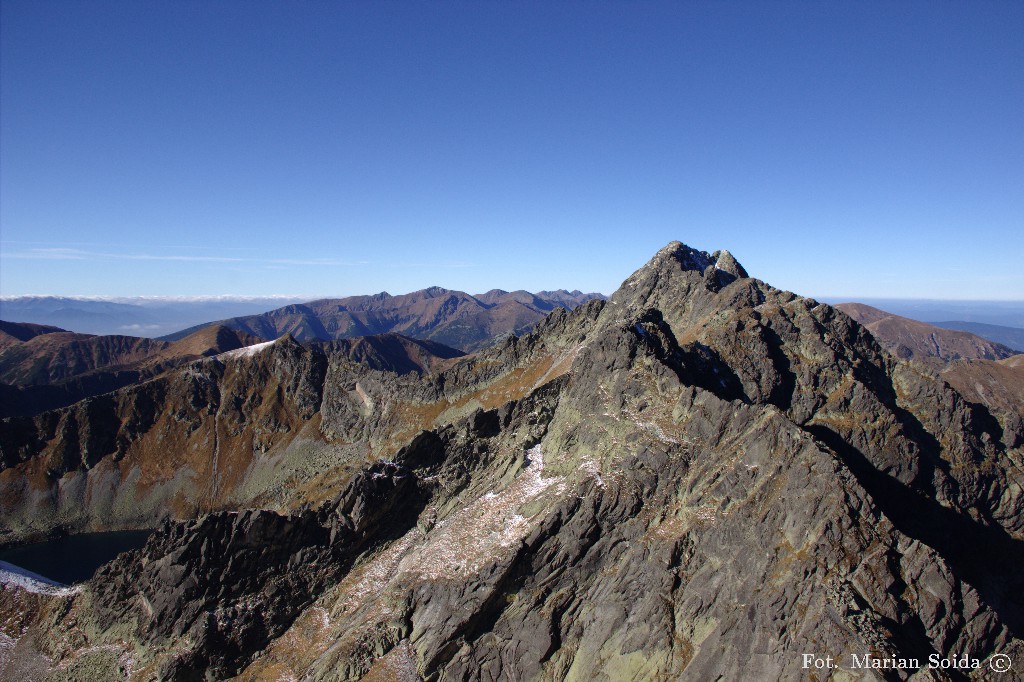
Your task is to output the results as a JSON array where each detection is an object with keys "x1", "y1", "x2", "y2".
[{"x1": 0, "y1": 327, "x2": 544, "y2": 544}]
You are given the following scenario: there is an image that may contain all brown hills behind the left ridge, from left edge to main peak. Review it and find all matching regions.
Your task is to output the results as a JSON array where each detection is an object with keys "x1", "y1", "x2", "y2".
[{"x1": 0, "y1": 287, "x2": 602, "y2": 416}]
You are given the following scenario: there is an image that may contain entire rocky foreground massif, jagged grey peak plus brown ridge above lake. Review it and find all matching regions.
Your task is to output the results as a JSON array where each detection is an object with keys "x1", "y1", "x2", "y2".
[{"x1": 0, "y1": 243, "x2": 1024, "y2": 680}]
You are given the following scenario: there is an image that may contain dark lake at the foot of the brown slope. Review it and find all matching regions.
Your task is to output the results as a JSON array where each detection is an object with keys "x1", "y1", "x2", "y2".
[{"x1": 0, "y1": 530, "x2": 151, "y2": 585}]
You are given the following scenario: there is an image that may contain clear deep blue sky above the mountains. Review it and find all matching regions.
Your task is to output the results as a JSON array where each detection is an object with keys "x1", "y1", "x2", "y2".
[{"x1": 0, "y1": 0, "x2": 1024, "y2": 299}]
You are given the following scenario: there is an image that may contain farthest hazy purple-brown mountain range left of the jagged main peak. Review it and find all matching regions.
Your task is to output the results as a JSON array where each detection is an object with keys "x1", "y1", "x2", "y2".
[{"x1": 163, "y1": 287, "x2": 604, "y2": 352}]
